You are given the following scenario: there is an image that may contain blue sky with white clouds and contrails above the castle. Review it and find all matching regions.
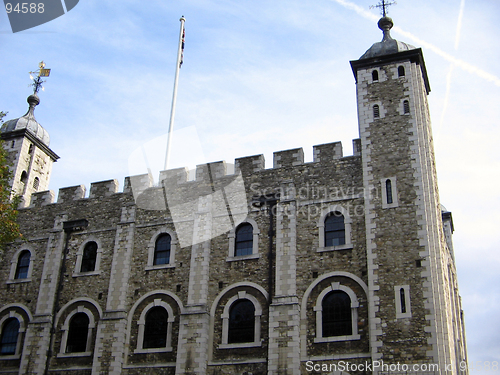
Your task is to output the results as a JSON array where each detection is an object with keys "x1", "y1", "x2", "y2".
[{"x1": 0, "y1": 0, "x2": 500, "y2": 373}]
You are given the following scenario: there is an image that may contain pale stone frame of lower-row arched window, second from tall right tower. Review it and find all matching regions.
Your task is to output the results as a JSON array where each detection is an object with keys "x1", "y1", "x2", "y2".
[{"x1": 218, "y1": 291, "x2": 262, "y2": 349}]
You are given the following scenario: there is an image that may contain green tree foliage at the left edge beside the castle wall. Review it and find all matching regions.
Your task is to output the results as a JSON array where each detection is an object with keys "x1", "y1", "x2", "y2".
[{"x1": 0, "y1": 112, "x2": 21, "y2": 254}]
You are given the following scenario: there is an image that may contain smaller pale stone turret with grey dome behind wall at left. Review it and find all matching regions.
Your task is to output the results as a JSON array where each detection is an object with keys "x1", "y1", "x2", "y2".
[{"x1": 0, "y1": 92, "x2": 59, "y2": 207}]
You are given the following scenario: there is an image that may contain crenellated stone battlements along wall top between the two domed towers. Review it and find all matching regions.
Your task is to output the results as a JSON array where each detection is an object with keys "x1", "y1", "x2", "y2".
[{"x1": 25, "y1": 139, "x2": 361, "y2": 208}]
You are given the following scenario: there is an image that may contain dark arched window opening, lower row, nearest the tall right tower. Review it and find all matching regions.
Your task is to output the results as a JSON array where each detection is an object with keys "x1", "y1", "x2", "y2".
[{"x1": 322, "y1": 290, "x2": 352, "y2": 337}]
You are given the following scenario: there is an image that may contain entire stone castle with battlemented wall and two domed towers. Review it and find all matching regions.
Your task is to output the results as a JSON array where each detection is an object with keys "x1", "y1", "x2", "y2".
[{"x1": 0, "y1": 13, "x2": 467, "y2": 375}]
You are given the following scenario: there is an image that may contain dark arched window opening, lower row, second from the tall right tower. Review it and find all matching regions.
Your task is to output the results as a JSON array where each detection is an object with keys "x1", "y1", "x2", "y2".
[{"x1": 228, "y1": 299, "x2": 255, "y2": 344}]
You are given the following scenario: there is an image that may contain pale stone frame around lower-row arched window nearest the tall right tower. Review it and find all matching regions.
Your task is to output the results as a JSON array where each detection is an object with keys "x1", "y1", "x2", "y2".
[{"x1": 314, "y1": 282, "x2": 361, "y2": 343}]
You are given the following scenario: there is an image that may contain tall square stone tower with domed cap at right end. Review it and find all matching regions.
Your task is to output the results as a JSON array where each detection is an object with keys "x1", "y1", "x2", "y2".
[{"x1": 351, "y1": 11, "x2": 466, "y2": 374}]
